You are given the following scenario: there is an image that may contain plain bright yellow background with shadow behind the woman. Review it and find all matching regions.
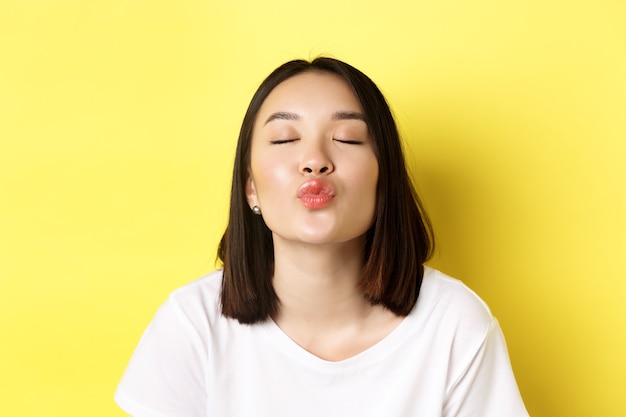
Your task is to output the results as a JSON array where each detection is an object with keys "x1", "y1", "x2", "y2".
[{"x1": 0, "y1": 0, "x2": 626, "y2": 417}]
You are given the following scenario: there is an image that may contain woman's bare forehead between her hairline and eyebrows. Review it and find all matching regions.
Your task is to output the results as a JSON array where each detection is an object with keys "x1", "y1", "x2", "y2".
[{"x1": 258, "y1": 71, "x2": 362, "y2": 117}]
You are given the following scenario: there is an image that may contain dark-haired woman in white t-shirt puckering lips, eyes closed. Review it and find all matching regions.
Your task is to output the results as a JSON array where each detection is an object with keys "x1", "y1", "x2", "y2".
[{"x1": 116, "y1": 58, "x2": 527, "y2": 417}]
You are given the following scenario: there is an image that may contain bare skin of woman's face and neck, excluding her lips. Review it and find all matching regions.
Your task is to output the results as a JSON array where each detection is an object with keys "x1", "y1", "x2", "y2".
[{"x1": 246, "y1": 72, "x2": 401, "y2": 361}]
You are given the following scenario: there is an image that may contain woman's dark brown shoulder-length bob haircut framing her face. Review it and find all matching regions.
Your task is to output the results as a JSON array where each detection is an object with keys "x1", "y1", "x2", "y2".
[{"x1": 218, "y1": 57, "x2": 434, "y2": 324}]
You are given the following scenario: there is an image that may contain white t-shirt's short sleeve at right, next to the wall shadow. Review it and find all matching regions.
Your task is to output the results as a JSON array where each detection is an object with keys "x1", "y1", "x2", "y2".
[{"x1": 443, "y1": 319, "x2": 528, "y2": 417}]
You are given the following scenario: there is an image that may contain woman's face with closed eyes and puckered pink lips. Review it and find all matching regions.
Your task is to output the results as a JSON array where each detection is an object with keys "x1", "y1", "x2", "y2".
[{"x1": 246, "y1": 72, "x2": 378, "y2": 244}]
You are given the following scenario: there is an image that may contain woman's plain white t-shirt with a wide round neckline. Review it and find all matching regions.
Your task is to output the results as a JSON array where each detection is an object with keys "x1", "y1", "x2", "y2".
[{"x1": 115, "y1": 268, "x2": 528, "y2": 417}]
